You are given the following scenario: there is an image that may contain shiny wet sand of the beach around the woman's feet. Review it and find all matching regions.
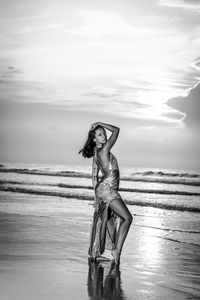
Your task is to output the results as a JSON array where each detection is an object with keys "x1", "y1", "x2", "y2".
[{"x1": 0, "y1": 192, "x2": 200, "y2": 300}]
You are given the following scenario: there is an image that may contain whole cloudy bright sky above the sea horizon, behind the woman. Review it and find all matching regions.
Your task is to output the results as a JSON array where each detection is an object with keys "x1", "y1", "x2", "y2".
[{"x1": 0, "y1": 0, "x2": 200, "y2": 171}]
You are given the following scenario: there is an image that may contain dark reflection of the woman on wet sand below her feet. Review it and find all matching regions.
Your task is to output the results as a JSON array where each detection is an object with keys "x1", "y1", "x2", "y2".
[{"x1": 87, "y1": 262, "x2": 126, "y2": 300}]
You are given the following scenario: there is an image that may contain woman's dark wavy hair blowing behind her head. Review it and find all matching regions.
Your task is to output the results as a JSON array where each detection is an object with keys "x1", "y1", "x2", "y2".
[{"x1": 78, "y1": 125, "x2": 104, "y2": 158}]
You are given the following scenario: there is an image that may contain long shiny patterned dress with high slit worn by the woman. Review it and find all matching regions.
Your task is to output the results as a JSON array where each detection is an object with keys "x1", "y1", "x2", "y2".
[{"x1": 89, "y1": 150, "x2": 123, "y2": 258}]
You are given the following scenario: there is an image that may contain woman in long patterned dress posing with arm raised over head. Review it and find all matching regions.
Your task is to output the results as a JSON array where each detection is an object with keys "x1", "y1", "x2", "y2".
[{"x1": 79, "y1": 122, "x2": 132, "y2": 263}]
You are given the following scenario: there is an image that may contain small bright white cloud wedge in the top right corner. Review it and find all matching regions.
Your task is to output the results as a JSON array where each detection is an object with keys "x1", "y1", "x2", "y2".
[{"x1": 159, "y1": 0, "x2": 200, "y2": 14}]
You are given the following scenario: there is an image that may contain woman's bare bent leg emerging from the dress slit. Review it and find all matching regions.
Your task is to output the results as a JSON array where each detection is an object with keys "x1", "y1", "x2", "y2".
[{"x1": 109, "y1": 199, "x2": 133, "y2": 262}]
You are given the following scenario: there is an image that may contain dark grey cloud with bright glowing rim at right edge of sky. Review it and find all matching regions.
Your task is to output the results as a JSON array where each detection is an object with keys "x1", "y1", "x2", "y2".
[{"x1": 167, "y1": 82, "x2": 200, "y2": 129}]
